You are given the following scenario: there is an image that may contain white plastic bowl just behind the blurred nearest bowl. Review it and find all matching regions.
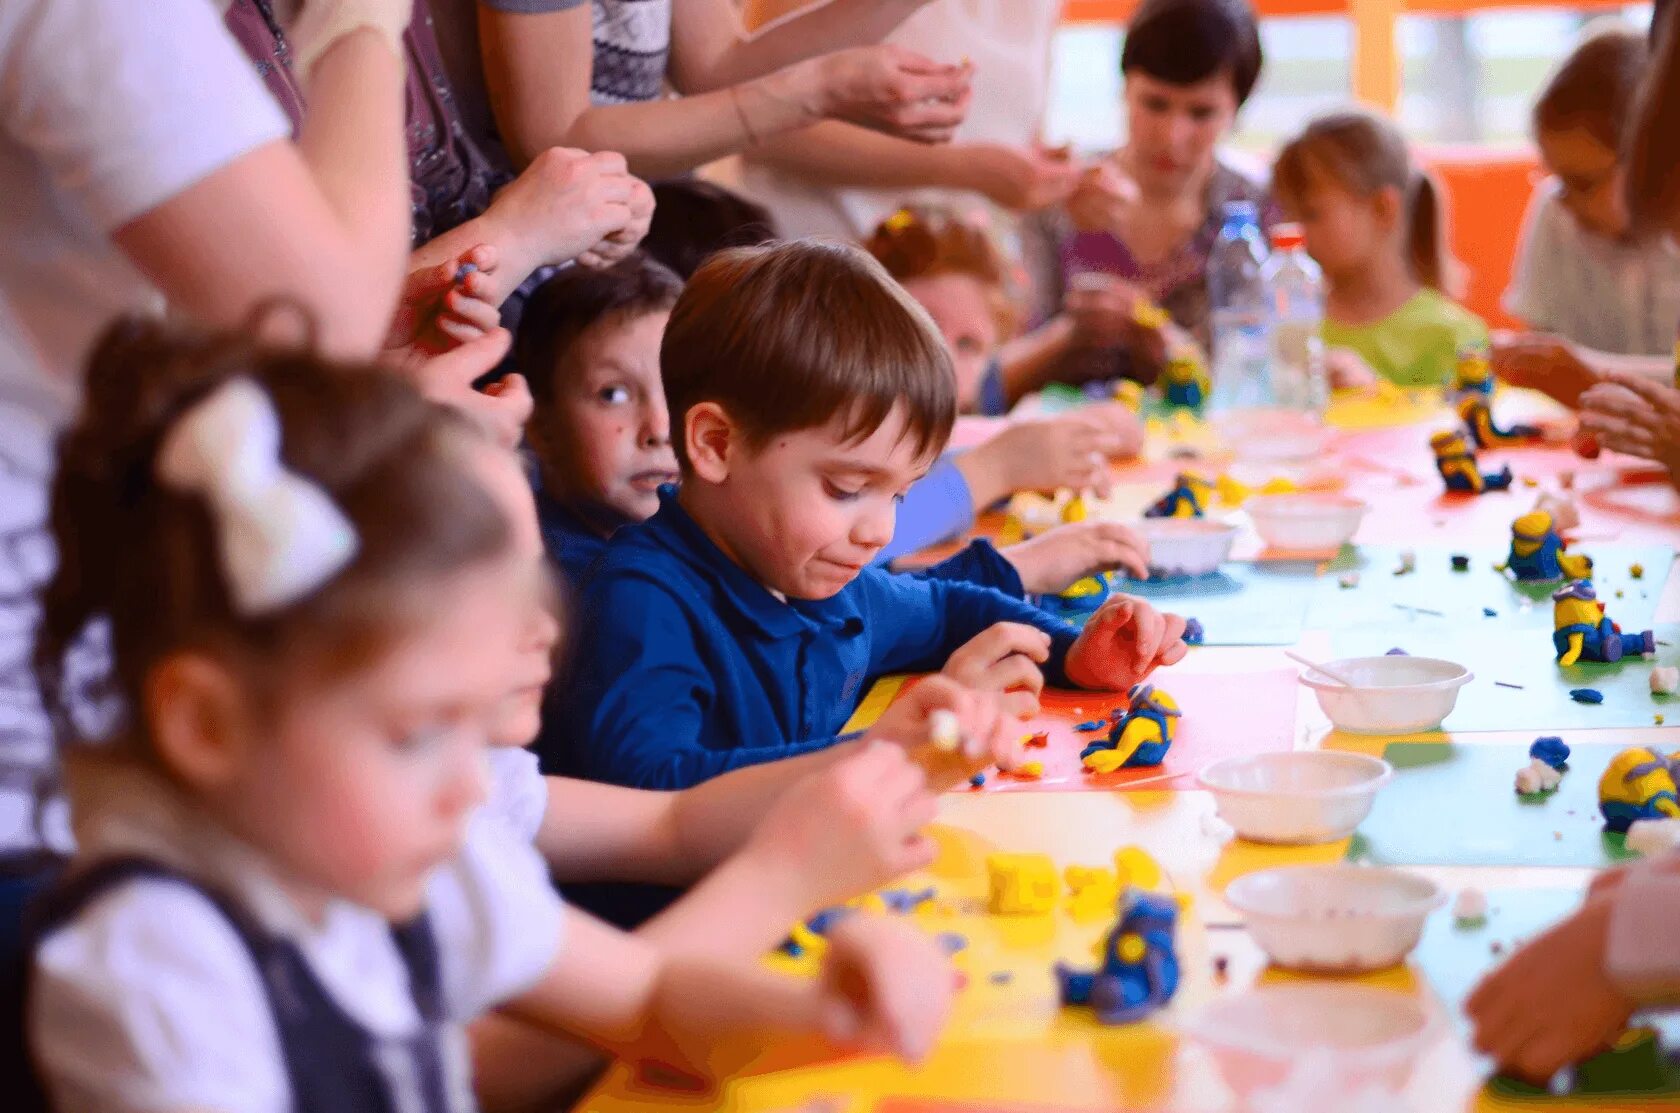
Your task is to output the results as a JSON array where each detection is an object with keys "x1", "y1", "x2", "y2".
[{"x1": 1225, "y1": 864, "x2": 1446, "y2": 973}]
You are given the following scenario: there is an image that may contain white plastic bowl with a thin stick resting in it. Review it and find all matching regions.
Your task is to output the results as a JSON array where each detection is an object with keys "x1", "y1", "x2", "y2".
[{"x1": 1300, "y1": 654, "x2": 1473, "y2": 735}]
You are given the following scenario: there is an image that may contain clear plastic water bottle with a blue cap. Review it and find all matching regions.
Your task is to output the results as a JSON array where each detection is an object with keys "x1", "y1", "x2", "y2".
[{"x1": 1208, "y1": 202, "x2": 1272, "y2": 412}]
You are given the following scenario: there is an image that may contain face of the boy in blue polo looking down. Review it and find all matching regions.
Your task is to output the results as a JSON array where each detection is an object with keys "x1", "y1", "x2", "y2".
[{"x1": 684, "y1": 407, "x2": 932, "y2": 599}]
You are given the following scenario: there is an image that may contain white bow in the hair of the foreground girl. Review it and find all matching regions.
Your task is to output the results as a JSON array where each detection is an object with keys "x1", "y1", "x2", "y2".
[{"x1": 156, "y1": 378, "x2": 356, "y2": 617}]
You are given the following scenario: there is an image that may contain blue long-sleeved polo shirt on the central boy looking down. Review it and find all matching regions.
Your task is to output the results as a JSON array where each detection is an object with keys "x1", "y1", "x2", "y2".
[{"x1": 538, "y1": 489, "x2": 1077, "y2": 789}]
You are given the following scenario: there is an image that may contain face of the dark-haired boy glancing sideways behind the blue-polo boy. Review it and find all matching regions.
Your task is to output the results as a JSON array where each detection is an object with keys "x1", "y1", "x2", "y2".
[{"x1": 531, "y1": 309, "x2": 677, "y2": 521}]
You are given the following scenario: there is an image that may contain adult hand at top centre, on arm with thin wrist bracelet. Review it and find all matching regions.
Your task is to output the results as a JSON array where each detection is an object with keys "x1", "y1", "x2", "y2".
[{"x1": 811, "y1": 44, "x2": 973, "y2": 143}]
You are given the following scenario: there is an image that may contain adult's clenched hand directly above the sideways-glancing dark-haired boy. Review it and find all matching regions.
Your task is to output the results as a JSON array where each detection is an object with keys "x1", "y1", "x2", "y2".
[{"x1": 480, "y1": 146, "x2": 654, "y2": 285}]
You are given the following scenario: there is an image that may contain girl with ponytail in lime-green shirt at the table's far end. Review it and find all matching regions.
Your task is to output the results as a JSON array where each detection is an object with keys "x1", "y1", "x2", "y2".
[{"x1": 1272, "y1": 111, "x2": 1488, "y2": 387}]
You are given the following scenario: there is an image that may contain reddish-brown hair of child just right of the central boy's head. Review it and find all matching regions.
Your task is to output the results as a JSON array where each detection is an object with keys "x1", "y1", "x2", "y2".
[{"x1": 864, "y1": 205, "x2": 1020, "y2": 338}]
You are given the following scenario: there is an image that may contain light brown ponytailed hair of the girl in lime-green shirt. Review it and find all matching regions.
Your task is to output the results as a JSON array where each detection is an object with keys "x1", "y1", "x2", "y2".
[{"x1": 1272, "y1": 109, "x2": 1455, "y2": 291}]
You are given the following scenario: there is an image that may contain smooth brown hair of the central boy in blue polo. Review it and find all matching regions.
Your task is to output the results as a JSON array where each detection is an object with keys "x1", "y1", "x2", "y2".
[{"x1": 659, "y1": 240, "x2": 956, "y2": 471}]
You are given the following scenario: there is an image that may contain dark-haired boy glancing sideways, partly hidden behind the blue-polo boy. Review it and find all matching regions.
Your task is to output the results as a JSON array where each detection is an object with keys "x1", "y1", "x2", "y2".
[{"x1": 516, "y1": 254, "x2": 682, "y2": 582}]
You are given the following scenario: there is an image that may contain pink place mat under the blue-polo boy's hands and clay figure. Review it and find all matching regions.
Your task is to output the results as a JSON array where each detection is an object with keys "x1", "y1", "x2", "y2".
[{"x1": 893, "y1": 669, "x2": 1295, "y2": 792}]
